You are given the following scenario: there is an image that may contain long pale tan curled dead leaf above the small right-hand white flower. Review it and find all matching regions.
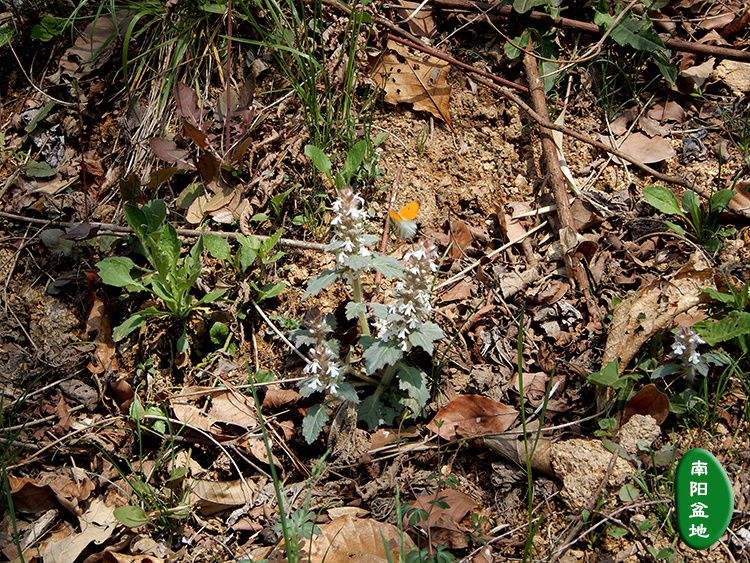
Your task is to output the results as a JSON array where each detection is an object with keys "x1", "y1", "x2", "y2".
[{"x1": 602, "y1": 253, "x2": 717, "y2": 373}]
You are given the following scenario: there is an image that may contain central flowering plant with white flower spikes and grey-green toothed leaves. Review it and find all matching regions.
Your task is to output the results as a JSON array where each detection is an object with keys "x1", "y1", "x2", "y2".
[{"x1": 293, "y1": 149, "x2": 443, "y2": 443}]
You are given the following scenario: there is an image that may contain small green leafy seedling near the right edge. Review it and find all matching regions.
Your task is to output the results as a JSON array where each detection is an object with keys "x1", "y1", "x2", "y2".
[{"x1": 643, "y1": 186, "x2": 735, "y2": 252}]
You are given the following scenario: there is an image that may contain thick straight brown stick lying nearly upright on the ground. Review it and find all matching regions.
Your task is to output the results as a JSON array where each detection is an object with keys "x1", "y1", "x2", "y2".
[{"x1": 523, "y1": 46, "x2": 601, "y2": 322}]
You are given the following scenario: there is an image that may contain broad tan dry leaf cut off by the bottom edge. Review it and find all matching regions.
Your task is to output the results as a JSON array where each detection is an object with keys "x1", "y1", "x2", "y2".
[{"x1": 300, "y1": 516, "x2": 415, "y2": 563}]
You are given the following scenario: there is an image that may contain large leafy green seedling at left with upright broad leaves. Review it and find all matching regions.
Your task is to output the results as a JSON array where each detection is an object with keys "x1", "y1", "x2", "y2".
[{"x1": 97, "y1": 199, "x2": 224, "y2": 346}]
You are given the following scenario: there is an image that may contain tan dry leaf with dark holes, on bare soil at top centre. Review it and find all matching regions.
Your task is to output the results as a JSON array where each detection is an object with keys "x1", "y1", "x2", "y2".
[{"x1": 372, "y1": 41, "x2": 453, "y2": 129}]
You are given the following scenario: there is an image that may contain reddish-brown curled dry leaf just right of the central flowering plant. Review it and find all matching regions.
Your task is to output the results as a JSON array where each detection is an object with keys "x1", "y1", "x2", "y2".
[{"x1": 427, "y1": 395, "x2": 518, "y2": 440}]
